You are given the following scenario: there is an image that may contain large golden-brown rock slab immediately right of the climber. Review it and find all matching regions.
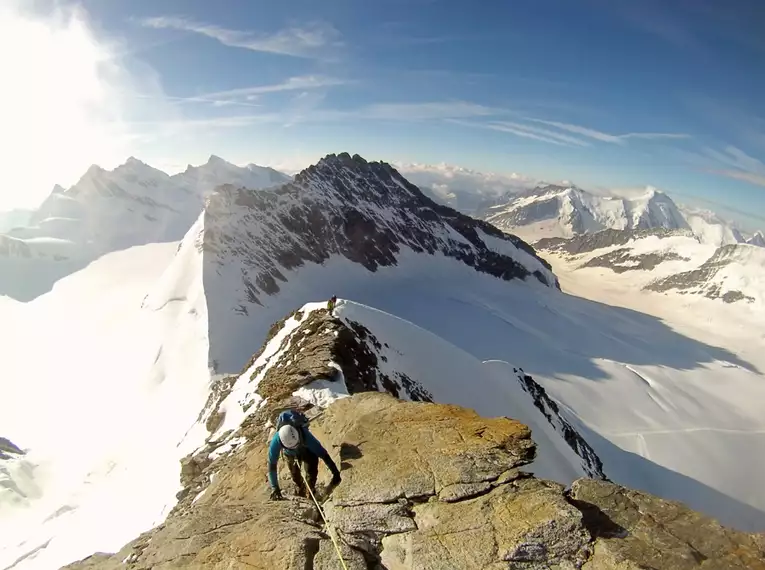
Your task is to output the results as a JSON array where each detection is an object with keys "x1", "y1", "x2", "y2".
[{"x1": 322, "y1": 392, "x2": 535, "y2": 506}]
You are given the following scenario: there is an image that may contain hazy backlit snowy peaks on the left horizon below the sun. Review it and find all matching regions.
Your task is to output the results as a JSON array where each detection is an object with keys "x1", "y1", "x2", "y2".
[{"x1": 0, "y1": 156, "x2": 289, "y2": 301}]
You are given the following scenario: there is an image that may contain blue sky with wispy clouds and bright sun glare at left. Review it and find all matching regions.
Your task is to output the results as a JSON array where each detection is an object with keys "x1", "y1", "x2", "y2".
[{"x1": 0, "y1": 0, "x2": 765, "y2": 229}]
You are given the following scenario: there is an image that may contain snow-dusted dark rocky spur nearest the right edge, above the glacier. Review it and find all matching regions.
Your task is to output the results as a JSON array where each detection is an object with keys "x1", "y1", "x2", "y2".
[{"x1": 645, "y1": 244, "x2": 755, "y2": 303}]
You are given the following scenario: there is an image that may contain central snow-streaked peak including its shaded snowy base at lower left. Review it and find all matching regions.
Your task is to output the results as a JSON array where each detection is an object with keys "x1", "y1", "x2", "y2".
[{"x1": 187, "y1": 153, "x2": 558, "y2": 372}]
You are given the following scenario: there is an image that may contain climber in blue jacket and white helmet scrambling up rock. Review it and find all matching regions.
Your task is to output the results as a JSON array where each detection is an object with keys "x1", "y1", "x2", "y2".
[{"x1": 268, "y1": 410, "x2": 341, "y2": 501}]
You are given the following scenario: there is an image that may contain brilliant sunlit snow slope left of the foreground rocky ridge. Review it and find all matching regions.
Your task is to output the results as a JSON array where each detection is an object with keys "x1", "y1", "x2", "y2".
[{"x1": 0, "y1": 239, "x2": 210, "y2": 569}]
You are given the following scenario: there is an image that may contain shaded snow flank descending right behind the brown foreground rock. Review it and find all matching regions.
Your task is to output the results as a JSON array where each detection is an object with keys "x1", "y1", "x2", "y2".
[{"x1": 335, "y1": 301, "x2": 605, "y2": 481}]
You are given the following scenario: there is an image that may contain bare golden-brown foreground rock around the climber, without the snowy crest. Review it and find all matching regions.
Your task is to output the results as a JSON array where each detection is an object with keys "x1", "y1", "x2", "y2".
[{"x1": 62, "y1": 393, "x2": 765, "y2": 570}]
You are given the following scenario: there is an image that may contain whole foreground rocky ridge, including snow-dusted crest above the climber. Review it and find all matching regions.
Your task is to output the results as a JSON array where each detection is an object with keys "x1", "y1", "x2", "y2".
[{"x1": 66, "y1": 310, "x2": 765, "y2": 570}]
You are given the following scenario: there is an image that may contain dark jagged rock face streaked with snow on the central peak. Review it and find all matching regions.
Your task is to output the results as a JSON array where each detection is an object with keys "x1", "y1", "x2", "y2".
[{"x1": 202, "y1": 153, "x2": 558, "y2": 303}]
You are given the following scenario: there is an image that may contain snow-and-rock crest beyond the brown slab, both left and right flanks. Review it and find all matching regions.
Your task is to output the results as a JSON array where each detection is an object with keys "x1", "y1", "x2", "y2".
[{"x1": 178, "y1": 300, "x2": 605, "y2": 510}]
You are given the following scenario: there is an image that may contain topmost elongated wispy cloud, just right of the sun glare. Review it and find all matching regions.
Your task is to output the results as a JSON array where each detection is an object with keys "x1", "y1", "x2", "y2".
[{"x1": 141, "y1": 16, "x2": 342, "y2": 59}]
